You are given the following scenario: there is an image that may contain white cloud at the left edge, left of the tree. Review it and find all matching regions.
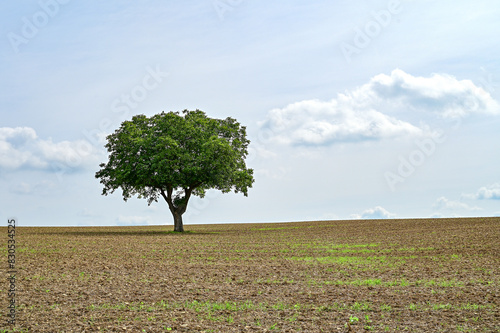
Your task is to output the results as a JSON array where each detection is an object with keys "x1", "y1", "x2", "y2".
[{"x1": 0, "y1": 127, "x2": 98, "y2": 171}]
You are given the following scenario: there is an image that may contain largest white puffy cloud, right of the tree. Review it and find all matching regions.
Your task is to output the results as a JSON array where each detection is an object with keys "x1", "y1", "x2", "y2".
[{"x1": 260, "y1": 69, "x2": 500, "y2": 145}]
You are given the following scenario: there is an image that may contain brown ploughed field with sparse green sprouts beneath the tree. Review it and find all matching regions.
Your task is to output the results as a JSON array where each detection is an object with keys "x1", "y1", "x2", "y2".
[{"x1": 0, "y1": 218, "x2": 500, "y2": 332}]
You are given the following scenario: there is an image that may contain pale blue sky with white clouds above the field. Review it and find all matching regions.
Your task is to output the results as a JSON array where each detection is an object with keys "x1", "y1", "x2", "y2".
[{"x1": 0, "y1": 0, "x2": 500, "y2": 228}]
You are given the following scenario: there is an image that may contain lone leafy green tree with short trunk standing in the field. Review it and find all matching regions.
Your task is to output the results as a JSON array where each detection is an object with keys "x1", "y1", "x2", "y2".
[{"x1": 95, "y1": 110, "x2": 254, "y2": 232}]
